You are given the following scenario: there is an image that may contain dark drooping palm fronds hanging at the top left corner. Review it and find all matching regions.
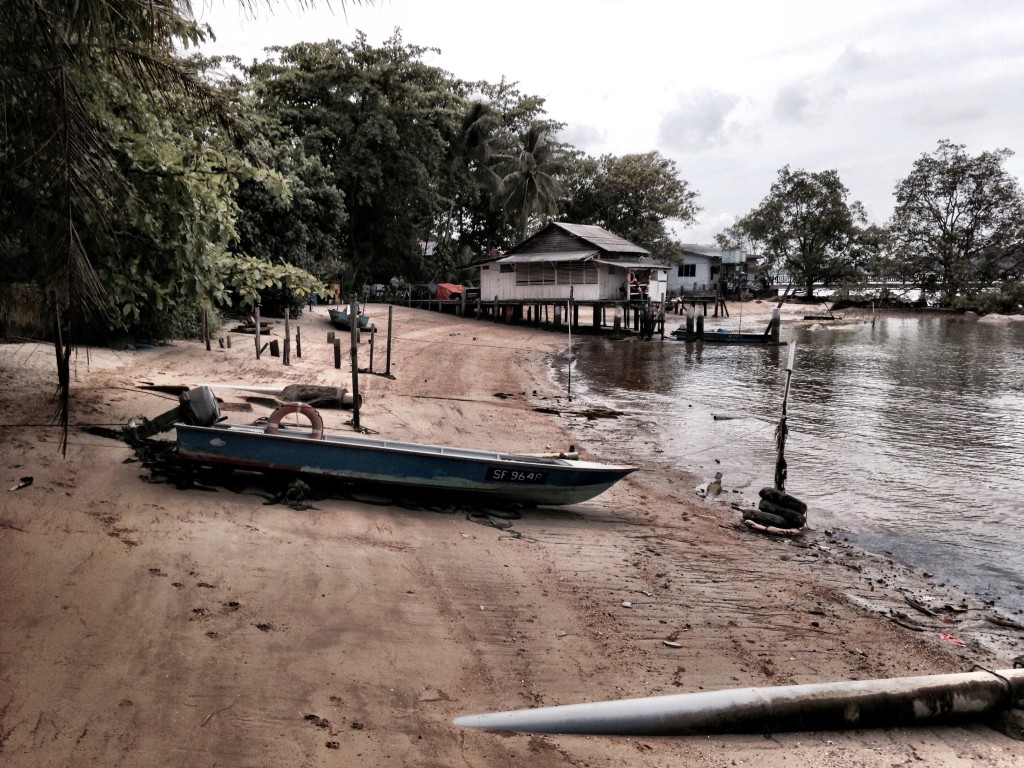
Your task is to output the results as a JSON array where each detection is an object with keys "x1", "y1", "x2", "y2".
[{"x1": 0, "y1": 0, "x2": 359, "y2": 446}]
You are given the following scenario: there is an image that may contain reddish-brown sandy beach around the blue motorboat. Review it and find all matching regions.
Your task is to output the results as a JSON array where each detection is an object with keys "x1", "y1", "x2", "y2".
[{"x1": 0, "y1": 302, "x2": 1024, "y2": 768}]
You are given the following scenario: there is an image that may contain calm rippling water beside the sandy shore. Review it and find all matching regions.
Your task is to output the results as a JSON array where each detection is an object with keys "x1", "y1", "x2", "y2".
[{"x1": 558, "y1": 316, "x2": 1024, "y2": 610}]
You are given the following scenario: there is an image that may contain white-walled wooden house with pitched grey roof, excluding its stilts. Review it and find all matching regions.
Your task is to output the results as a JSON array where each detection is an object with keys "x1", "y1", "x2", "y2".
[{"x1": 479, "y1": 222, "x2": 669, "y2": 302}]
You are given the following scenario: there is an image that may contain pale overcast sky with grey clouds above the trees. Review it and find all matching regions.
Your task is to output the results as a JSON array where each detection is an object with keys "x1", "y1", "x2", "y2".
[{"x1": 196, "y1": 0, "x2": 1024, "y2": 244}]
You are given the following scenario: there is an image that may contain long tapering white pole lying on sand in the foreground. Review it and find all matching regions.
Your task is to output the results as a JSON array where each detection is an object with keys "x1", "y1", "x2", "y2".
[{"x1": 455, "y1": 670, "x2": 1024, "y2": 736}]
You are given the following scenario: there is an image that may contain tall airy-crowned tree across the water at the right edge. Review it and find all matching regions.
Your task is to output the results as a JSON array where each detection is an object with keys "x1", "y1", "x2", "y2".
[{"x1": 890, "y1": 139, "x2": 1024, "y2": 305}]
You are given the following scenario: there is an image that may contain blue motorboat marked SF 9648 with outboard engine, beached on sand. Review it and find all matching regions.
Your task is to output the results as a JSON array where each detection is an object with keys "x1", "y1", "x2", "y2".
[{"x1": 126, "y1": 386, "x2": 637, "y2": 505}]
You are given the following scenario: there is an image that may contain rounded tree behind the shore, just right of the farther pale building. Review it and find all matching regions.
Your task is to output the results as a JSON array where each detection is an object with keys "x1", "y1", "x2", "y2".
[{"x1": 732, "y1": 166, "x2": 866, "y2": 298}]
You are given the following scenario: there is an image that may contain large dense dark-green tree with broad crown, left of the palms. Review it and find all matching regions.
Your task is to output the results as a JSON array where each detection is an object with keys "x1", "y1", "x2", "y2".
[{"x1": 247, "y1": 32, "x2": 462, "y2": 281}]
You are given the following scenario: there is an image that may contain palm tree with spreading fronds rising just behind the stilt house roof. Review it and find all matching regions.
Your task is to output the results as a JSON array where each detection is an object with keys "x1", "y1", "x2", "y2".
[{"x1": 495, "y1": 123, "x2": 564, "y2": 240}]
